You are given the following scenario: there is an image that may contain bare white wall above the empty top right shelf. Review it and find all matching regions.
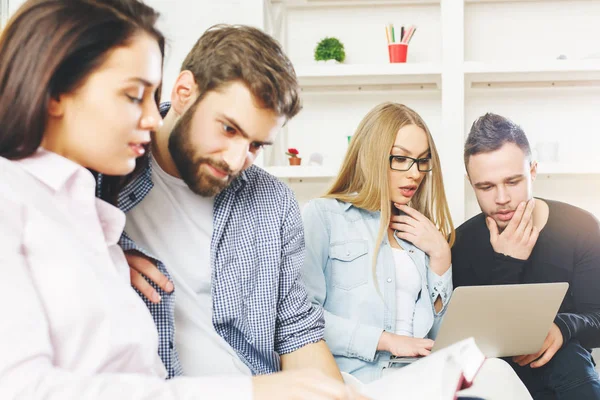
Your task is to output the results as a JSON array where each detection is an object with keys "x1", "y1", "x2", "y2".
[{"x1": 465, "y1": 0, "x2": 600, "y2": 61}]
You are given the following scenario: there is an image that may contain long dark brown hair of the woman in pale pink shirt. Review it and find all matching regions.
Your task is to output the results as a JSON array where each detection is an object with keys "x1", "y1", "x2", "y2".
[{"x1": 0, "y1": 0, "x2": 165, "y2": 200}]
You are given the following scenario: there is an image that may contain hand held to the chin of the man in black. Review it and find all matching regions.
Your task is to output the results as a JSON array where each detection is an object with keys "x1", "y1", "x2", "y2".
[{"x1": 485, "y1": 199, "x2": 540, "y2": 260}]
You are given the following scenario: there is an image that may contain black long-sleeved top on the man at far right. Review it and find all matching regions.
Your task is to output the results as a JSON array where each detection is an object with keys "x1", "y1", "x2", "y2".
[{"x1": 452, "y1": 200, "x2": 600, "y2": 348}]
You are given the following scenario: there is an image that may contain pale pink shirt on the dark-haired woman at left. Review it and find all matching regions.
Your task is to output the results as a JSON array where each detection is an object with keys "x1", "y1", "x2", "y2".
[{"x1": 0, "y1": 150, "x2": 252, "y2": 400}]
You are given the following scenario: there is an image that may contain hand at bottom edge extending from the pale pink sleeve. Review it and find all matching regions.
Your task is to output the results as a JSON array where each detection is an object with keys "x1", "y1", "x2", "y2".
[{"x1": 252, "y1": 369, "x2": 367, "y2": 400}]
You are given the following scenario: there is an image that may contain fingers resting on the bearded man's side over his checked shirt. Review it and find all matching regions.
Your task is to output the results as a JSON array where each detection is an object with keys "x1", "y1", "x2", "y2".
[{"x1": 125, "y1": 251, "x2": 174, "y2": 303}]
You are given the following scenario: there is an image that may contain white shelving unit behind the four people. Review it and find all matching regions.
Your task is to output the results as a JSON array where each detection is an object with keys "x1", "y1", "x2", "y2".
[{"x1": 265, "y1": 0, "x2": 600, "y2": 225}]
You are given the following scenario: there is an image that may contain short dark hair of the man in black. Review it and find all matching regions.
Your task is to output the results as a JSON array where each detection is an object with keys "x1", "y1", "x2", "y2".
[{"x1": 464, "y1": 113, "x2": 531, "y2": 168}]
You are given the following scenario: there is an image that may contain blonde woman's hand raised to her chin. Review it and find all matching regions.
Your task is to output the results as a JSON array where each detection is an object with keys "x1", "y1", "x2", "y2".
[{"x1": 390, "y1": 203, "x2": 451, "y2": 276}]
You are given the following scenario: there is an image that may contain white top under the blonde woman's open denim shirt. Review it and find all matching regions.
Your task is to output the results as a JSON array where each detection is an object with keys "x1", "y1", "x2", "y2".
[{"x1": 392, "y1": 247, "x2": 421, "y2": 337}]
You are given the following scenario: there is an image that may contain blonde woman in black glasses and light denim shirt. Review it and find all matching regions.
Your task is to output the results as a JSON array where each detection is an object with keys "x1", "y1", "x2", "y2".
[{"x1": 303, "y1": 103, "x2": 454, "y2": 382}]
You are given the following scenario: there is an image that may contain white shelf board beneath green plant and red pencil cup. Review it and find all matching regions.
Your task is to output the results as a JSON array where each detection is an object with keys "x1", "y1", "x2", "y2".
[{"x1": 296, "y1": 63, "x2": 442, "y2": 91}]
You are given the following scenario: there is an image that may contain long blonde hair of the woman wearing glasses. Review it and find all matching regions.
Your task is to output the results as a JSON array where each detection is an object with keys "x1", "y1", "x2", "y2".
[{"x1": 325, "y1": 102, "x2": 455, "y2": 282}]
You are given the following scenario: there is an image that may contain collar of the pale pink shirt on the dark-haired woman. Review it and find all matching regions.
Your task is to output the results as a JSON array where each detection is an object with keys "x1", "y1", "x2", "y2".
[{"x1": 16, "y1": 147, "x2": 125, "y2": 245}]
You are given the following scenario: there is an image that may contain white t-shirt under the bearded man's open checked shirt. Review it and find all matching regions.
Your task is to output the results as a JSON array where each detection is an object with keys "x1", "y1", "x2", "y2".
[{"x1": 125, "y1": 157, "x2": 251, "y2": 376}]
